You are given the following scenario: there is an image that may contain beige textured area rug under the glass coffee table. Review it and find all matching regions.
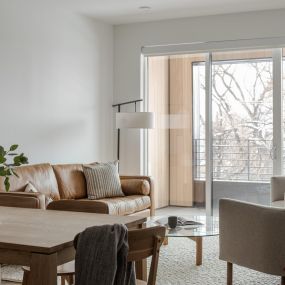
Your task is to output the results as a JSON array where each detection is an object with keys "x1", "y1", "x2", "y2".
[{"x1": 0, "y1": 237, "x2": 280, "y2": 285}]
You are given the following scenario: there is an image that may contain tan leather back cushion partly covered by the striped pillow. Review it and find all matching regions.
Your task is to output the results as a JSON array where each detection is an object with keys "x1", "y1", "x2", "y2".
[{"x1": 53, "y1": 164, "x2": 87, "y2": 199}]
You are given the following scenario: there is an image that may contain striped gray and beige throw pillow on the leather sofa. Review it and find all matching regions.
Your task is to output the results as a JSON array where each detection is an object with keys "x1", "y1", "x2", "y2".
[{"x1": 83, "y1": 161, "x2": 124, "y2": 200}]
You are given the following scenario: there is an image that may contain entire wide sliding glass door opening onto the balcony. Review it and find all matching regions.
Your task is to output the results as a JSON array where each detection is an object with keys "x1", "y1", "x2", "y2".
[{"x1": 145, "y1": 45, "x2": 285, "y2": 215}]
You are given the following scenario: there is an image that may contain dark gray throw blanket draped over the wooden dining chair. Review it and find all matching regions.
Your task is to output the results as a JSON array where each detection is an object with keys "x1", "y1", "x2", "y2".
[{"x1": 74, "y1": 224, "x2": 136, "y2": 285}]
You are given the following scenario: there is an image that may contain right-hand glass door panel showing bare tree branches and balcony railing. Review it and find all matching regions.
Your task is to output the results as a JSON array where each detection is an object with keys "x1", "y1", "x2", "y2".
[{"x1": 211, "y1": 50, "x2": 274, "y2": 213}]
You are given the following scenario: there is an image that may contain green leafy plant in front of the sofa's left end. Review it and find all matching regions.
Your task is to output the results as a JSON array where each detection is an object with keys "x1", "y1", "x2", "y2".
[{"x1": 0, "y1": 144, "x2": 28, "y2": 192}]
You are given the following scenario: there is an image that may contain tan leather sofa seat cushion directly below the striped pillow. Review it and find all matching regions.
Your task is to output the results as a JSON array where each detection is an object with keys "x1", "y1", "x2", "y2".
[{"x1": 77, "y1": 195, "x2": 151, "y2": 216}]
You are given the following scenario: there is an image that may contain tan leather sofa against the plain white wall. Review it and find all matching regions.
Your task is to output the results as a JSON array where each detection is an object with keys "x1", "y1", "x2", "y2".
[{"x1": 0, "y1": 163, "x2": 154, "y2": 217}]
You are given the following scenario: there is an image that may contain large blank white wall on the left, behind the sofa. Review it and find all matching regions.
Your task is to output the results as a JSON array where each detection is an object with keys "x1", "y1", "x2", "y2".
[{"x1": 0, "y1": 1, "x2": 114, "y2": 163}]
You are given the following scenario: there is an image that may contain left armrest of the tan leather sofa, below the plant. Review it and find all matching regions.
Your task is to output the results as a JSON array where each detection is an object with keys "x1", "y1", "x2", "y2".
[{"x1": 0, "y1": 192, "x2": 45, "y2": 209}]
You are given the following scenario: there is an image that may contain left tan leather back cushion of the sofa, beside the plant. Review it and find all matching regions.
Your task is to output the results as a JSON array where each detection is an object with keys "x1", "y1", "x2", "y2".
[{"x1": 0, "y1": 163, "x2": 59, "y2": 200}]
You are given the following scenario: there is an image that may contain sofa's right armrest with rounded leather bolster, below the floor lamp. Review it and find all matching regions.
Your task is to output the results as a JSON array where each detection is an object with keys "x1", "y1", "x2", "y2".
[{"x1": 120, "y1": 175, "x2": 155, "y2": 216}]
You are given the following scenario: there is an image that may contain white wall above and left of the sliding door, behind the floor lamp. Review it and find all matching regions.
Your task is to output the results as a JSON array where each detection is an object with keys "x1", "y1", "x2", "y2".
[{"x1": 114, "y1": 10, "x2": 285, "y2": 174}]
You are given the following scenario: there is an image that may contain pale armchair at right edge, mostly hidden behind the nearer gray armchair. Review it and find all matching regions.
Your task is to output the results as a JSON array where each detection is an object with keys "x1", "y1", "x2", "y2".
[{"x1": 270, "y1": 176, "x2": 285, "y2": 208}]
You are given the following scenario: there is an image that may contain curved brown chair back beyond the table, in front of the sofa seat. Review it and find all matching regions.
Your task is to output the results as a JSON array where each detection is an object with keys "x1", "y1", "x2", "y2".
[{"x1": 47, "y1": 199, "x2": 109, "y2": 214}]
